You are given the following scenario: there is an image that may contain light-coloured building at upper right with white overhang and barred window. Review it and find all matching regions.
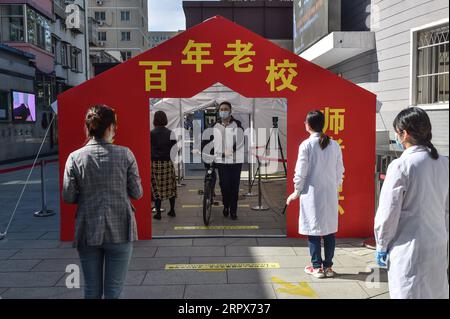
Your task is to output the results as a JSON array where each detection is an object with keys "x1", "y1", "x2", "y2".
[{"x1": 294, "y1": 0, "x2": 449, "y2": 156}]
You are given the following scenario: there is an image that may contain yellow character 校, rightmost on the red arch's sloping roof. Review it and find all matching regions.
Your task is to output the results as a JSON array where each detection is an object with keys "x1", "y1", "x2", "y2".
[{"x1": 266, "y1": 59, "x2": 298, "y2": 92}]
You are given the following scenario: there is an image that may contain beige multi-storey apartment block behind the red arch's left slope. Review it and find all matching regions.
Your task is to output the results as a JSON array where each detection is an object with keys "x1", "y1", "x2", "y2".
[{"x1": 88, "y1": 0, "x2": 149, "y2": 61}]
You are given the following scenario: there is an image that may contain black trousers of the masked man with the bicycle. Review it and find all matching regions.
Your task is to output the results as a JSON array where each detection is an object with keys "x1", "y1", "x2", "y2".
[{"x1": 216, "y1": 164, "x2": 242, "y2": 215}]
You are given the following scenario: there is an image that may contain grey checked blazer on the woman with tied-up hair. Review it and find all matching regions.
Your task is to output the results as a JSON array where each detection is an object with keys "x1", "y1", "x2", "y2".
[{"x1": 62, "y1": 139, "x2": 142, "y2": 247}]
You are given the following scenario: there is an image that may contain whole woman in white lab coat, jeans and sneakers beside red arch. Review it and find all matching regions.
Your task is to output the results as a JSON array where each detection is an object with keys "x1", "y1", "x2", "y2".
[{"x1": 286, "y1": 111, "x2": 344, "y2": 278}]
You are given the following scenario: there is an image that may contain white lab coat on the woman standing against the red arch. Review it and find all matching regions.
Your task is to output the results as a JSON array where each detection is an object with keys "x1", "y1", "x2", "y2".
[{"x1": 294, "y1": 133, "x2": 344, "y2": 236}]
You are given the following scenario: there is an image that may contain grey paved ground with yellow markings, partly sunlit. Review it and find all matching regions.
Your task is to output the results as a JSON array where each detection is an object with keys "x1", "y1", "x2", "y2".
[{"x1": 0, "y1": 158, "x2": 389, "y2": 299}]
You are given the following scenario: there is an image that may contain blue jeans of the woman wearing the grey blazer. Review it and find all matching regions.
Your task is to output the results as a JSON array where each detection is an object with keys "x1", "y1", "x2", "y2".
[{"x1": 78, "y1": 242, "x2": 133, "y2": 299}]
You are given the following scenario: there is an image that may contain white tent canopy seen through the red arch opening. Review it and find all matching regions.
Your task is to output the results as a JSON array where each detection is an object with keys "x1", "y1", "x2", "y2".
[{"x1": 150, "y1": 83, "x2": 287, "y2": 176}]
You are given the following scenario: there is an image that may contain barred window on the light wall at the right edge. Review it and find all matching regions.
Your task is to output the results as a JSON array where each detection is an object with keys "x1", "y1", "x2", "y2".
[{"x1": 416, "y1": 24, "x2": 449, "y2": 104}]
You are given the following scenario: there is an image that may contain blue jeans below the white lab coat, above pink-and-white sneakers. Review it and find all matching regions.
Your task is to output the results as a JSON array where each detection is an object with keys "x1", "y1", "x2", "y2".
[{"x1": 308, "y1": 234, "x2": 336, "y2": 268}]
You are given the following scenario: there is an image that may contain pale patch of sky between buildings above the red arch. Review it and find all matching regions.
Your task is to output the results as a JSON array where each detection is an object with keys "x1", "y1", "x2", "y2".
[{"x1": 148, "y1": 0, "x2": 219, "y2": 31}]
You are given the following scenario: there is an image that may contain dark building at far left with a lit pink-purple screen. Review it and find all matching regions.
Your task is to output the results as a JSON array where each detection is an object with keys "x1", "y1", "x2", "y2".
[{"x1": 0, "y1": 0, "x2": 57, "y2": 162}]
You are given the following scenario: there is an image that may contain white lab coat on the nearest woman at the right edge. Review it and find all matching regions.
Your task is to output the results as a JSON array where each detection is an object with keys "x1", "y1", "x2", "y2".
[{"x1": 375, "y1": 146, "x2": 449, "y2": 299}]
